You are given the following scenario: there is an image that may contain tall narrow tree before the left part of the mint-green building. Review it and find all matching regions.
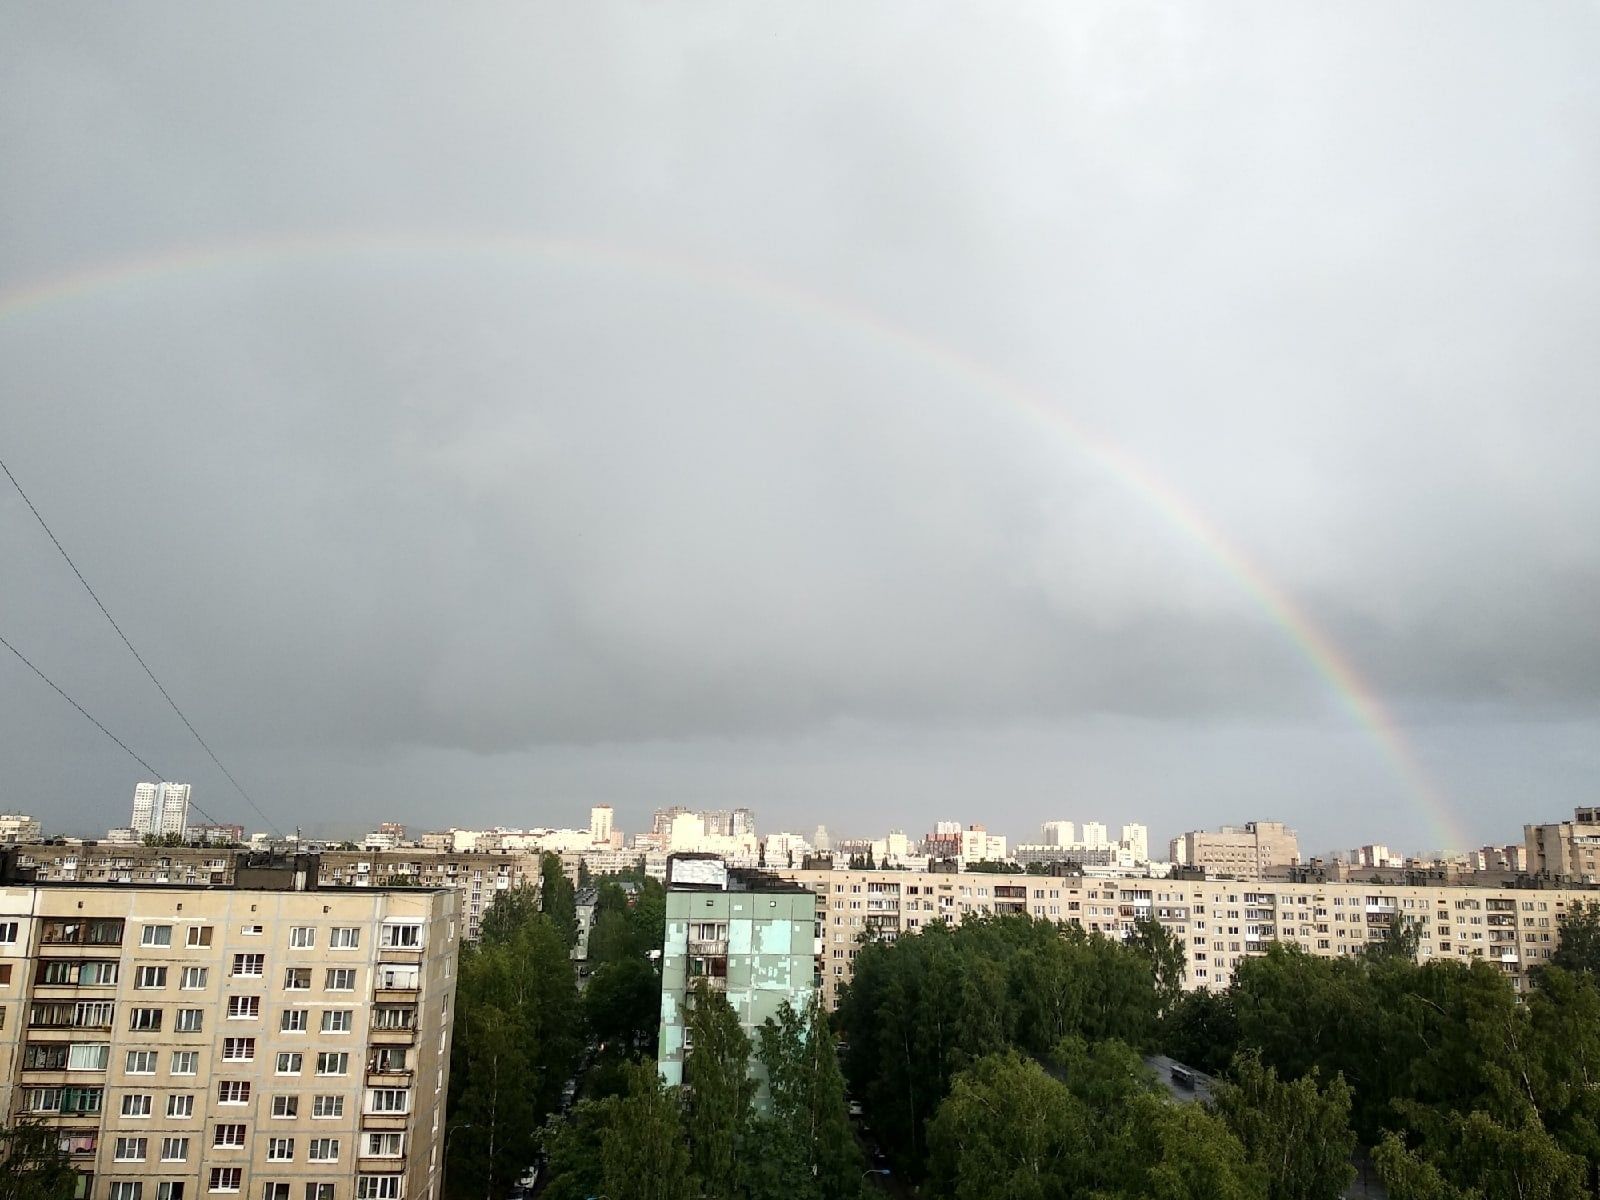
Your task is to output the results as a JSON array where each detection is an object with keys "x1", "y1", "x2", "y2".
[{"x1": 683, "y1": 979, "x2": 755, "y2": 1200}]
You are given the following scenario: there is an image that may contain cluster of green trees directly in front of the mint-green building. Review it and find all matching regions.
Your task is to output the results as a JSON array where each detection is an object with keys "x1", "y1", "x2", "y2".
[{"x1": 546, "y1": 981, "x2": 864, "y2": 1200}]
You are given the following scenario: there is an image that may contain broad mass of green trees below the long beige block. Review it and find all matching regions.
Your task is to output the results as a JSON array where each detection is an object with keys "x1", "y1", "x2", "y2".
[{"x1": 838, "y1": 906, "x2": 1600, "y2": 1200}]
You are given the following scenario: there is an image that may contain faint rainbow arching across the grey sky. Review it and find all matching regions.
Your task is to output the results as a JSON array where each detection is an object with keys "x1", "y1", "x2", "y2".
[{"x1": 0, "y1": 230, "x2": 1470, "y2": 850}]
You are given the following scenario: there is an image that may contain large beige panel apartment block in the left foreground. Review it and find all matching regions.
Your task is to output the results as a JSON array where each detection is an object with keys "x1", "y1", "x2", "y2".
[{"x1": 0, "y1": 856, "x2": 461, "y2": 1200}]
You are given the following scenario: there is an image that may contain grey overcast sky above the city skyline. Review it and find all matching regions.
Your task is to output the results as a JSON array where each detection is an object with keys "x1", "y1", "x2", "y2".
[{"x1": 0, "y1": 0, "x2": 1600, "y2": 850}]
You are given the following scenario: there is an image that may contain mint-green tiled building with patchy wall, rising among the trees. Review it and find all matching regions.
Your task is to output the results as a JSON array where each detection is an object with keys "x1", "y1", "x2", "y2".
[{"x1": 659, "y1": 854, "x2": 818, "y2": 1102}]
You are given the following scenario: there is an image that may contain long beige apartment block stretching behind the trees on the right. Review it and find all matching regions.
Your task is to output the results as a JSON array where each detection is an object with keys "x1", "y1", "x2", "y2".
[{"x1": 778, "y1": 870, "x2": 1597, "y2": 1008}]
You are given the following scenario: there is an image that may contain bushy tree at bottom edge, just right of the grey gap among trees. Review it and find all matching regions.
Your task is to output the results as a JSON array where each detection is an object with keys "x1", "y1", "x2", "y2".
[{"x1": 1211, "y1": 1053, "x2": 1355, "y2": 1200}]
